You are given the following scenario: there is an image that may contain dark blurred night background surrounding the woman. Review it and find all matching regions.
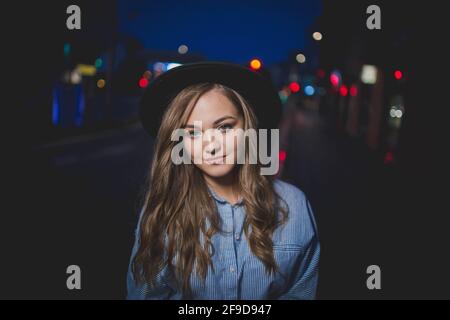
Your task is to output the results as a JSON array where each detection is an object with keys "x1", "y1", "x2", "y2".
[{"x1": 0, "y1": 0, "x2": 450, "y2": 299}]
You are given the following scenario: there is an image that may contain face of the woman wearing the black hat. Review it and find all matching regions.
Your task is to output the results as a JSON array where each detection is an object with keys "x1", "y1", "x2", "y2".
[{"x1": 183, "y1": 89, "x2": 244, "y2": 178}]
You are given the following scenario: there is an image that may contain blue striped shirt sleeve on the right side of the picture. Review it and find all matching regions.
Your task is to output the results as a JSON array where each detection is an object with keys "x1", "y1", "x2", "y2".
[{"x1": 278, "y1": 199, "x2": 320, "y2": 300}]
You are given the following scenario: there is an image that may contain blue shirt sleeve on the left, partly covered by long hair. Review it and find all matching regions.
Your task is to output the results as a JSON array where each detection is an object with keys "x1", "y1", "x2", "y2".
[{"x1": 127, "y1": 209, "x2": 174, "y2": 300}]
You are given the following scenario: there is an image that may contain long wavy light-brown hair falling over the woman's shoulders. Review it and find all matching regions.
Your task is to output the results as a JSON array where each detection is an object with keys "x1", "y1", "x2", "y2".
[{"x1": 132, "y1": 83, "x2": 288, "y2": 296}]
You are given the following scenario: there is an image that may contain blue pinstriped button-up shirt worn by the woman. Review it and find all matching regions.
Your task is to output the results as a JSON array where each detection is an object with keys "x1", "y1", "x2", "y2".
[{"x1": 127, "y1": 179, "x2": 320, "y2": 300}]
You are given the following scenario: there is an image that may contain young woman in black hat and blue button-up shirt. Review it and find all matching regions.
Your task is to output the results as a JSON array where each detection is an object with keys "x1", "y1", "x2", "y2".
[{"x1": 127, "y1": 62, "x2": 320, "y2": 299}]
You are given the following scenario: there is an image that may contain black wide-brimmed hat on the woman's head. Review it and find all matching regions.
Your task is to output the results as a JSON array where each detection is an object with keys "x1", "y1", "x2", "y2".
[{"x1": 139, "y1": 62, "x2": 281, "y2": 137}]
